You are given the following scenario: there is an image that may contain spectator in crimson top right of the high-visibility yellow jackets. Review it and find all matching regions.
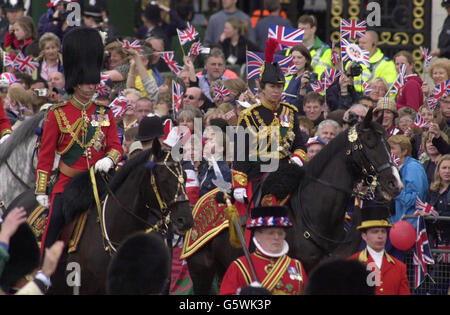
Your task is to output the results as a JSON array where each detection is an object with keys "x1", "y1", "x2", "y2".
[{"x1": 394, "y1": 50, "x2": 423, "y2": 112}]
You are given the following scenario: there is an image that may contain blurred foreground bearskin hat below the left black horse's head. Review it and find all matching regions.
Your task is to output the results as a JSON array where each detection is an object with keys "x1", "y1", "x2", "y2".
[{"x1": 107, "y1": 232, "x2": 171, "y2": 295}]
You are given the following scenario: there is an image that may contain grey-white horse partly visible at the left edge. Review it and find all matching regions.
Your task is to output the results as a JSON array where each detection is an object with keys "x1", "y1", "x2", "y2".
[{"x1": 0, "y1": 112, "x2": 46, "y2": 212}]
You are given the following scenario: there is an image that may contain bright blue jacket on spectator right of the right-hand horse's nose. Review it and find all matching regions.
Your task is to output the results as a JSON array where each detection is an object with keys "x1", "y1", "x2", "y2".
[{"x1": 391, "y1": 156, "x2": 428, "y2": 227}]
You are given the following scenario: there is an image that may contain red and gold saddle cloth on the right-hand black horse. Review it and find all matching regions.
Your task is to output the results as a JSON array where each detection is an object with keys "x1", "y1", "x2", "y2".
[{"x1": 180, "y1": 188, "x2": 228, "y2": 259}]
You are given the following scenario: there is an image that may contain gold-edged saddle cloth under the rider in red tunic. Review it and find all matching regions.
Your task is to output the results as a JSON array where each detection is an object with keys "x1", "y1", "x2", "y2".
[{"x1": 27, "y1": 206, "x2": 87, "y2": 253}]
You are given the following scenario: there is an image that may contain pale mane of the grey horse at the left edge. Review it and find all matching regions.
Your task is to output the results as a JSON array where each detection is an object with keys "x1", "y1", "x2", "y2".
[{"x1": 0, "y1": 112, "x2": 46, "y2": 165}]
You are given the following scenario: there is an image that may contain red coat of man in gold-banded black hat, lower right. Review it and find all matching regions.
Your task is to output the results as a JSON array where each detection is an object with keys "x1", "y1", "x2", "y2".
[{"x1": 350, "y1": 248, "x2": 411, "y2": 295}]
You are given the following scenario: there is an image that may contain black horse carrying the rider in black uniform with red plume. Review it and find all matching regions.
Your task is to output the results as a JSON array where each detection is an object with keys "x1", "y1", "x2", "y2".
[{"x1": 187, "y1": 111, "x2": 403, "y2": 294}]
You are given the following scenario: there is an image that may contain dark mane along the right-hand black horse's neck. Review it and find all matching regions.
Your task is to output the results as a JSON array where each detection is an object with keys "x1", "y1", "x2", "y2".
[{"x1": 305, "y1": 130, "x2": 348, "y2": 178}]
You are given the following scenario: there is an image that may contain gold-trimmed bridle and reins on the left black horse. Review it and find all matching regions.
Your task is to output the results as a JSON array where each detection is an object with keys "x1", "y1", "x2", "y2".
[{"x1": 99, "y1": 152, "x2": 189, "y2": 252}]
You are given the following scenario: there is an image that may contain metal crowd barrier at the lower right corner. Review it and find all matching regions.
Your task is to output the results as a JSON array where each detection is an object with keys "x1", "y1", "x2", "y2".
[{"x1": 402, "y1": 216, "x2": 450, "y2": 295}]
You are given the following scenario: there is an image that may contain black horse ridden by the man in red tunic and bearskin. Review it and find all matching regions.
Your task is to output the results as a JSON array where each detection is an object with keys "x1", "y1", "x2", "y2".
[{"x1": 8, "y1": 145, "x2": 193, "y2": 294}]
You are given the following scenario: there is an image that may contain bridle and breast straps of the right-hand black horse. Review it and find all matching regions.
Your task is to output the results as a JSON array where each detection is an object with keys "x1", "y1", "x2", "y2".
[{"x1": 302, "y1": 125, "x2": 394, "y2": 255}]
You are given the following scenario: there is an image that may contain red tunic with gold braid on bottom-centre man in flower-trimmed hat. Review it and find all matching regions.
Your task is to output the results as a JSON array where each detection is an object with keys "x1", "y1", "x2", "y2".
[{"x1": 220, "y1": 250, "x2": 307, "y2": 295}]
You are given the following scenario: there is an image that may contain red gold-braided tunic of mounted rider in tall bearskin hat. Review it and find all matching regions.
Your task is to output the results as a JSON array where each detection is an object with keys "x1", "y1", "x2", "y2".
[{"x1": 36, "y1": 98, "x2": 123, "y2": 194}]
